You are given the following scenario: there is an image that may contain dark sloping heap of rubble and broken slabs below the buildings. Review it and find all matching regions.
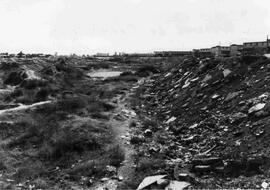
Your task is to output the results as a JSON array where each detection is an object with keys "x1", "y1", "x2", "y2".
[{"x1": 136, "y1": 56, "x2": 270, "y2": 188}]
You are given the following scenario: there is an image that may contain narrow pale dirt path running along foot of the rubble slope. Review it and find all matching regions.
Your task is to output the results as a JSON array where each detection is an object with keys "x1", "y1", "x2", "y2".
[{"x1": 93, "y1": 85, "x2": 138, "y2": 190}]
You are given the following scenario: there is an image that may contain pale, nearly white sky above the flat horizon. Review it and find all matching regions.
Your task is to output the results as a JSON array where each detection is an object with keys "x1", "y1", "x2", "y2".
[{"x1": 0, "y1": 0, "x2": 270, "y2": 55}]
